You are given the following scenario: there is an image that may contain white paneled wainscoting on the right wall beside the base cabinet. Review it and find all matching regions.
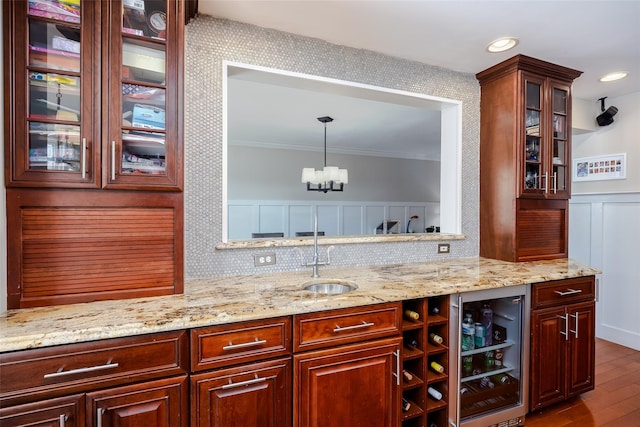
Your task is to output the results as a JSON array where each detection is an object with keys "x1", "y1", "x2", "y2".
[{"x1": 569, "y1": 193, "x2": 640, "y2": 350}]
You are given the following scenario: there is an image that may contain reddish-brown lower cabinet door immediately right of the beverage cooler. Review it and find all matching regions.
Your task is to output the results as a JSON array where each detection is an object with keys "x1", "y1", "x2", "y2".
[{"x1": 529, "y1": 307, "x2": 567, "y2": 411}]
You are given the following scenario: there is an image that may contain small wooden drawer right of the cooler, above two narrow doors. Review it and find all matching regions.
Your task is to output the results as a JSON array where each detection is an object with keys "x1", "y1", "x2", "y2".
[{"x1": 531, "y1": 276, "x2": 596, "y2": 309}]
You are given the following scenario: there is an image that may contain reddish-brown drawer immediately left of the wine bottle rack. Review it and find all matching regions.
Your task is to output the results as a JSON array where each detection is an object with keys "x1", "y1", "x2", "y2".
[{"x1": 293, "y1": 303, "x2": 402, "y2": 352}]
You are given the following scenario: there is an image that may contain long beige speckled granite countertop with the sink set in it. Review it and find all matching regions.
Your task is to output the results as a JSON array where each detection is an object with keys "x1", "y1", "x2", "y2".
[{"x1": 0, "y1": 258, "x2": 600, "y2": 352}]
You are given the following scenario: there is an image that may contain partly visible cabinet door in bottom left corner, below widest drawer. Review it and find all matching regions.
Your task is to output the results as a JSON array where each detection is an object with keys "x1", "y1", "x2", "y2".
[{"x1": 0, "y1": 394, "x2": 84, "y2": 427}]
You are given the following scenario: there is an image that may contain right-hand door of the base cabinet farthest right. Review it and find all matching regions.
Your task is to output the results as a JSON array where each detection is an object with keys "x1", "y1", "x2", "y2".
[{"x1": 567, "y1": 302, "x2": 595, "y2": 397}]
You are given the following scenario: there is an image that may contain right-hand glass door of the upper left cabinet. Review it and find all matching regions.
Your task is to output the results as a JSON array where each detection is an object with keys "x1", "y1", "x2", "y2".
[{"x1": 103, "y1": 0, "x2": 183, "y2": 189}]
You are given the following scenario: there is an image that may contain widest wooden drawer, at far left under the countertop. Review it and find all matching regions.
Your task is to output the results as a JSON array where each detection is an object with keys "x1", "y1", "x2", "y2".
[{"x1": 0, "y1": 331, "x2": 188, "y2": 407}]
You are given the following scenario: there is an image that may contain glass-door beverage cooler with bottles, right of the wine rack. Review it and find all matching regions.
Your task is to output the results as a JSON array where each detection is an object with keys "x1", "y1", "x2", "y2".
[{"x1": 449, "y1": 285, "x2": 531, "y2": 427}]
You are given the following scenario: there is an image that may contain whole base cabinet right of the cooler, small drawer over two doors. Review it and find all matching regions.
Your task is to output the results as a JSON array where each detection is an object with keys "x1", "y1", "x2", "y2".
[{"x1": 529, "y1": 276, "x2": 595, "y2": 411}]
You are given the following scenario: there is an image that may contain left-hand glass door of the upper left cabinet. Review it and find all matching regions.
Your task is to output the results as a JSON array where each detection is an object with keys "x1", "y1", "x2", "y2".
[{"x1": 3, "y1": 0, "x2": 100, "y2": 187}]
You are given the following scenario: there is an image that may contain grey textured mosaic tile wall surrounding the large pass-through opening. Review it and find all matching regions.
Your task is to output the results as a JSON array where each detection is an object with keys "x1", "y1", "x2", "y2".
[{"x1": 184, "y1": 15, "x2": 480, "y2": 279}]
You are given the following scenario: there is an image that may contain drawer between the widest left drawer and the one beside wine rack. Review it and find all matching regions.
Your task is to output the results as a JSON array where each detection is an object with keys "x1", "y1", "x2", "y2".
[{"x1": 191, "y1": 317, "x2": 291, "y2": 372}]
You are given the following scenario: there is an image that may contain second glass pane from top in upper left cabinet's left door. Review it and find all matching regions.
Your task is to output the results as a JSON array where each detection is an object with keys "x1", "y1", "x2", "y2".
[{"x1": 29, "y1": 19, "x2": 80, "y2": 72}]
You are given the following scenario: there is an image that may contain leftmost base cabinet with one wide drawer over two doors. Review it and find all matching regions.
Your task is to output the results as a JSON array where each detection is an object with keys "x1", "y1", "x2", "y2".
[{"x1": 0, "y1": 332, "x2": 188, "y2": 427}]
